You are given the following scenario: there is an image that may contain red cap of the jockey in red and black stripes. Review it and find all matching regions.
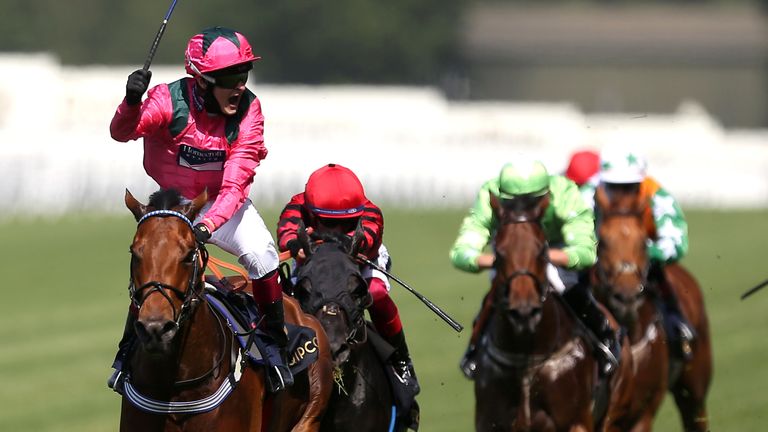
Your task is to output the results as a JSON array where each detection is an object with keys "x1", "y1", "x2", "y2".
[{"x1": 304, "y1": 164, "x2": 367, "y2": 218}]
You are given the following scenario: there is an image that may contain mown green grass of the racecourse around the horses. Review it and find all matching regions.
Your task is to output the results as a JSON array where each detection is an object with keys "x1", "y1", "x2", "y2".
[{"x1": 0, "y1": 208, "x2": 768, "y2": 432}]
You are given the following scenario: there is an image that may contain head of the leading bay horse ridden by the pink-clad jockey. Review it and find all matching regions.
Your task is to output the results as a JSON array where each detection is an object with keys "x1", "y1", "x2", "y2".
[{"x1": 125, "y1": 190, "x2": 208, "y2": 354}]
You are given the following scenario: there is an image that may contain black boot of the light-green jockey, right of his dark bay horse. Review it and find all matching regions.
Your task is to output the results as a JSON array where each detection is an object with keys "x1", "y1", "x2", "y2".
[{"x1": 563, "y1": 283, "x2": 621, "y2": 376}]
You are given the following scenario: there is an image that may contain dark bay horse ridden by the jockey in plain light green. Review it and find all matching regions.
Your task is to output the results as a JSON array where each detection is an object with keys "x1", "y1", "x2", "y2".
[{"x1": 475, "y1": 195, "x2": 631, "y2": 432}]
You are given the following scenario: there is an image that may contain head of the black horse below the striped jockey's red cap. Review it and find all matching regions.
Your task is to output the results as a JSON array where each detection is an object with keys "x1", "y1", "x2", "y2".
[{"x1": 294, "y1": 225, "x2": 372, "y2": 366}]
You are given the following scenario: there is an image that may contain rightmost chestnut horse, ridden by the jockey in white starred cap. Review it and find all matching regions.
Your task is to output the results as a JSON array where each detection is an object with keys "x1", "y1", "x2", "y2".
[{"x1": 592, "y1": 186, "x2": 712, "y2": 431}]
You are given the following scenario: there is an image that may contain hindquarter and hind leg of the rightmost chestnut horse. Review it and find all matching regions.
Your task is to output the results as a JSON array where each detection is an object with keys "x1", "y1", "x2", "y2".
[{"x1": 667, "y1": 265, "x2": 712, "y2": 431}]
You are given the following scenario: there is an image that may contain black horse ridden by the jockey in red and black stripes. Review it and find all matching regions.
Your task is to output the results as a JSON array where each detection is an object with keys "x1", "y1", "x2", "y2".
[{"x1": 293, "y1": 227, "x2": 405, "y2": 432}]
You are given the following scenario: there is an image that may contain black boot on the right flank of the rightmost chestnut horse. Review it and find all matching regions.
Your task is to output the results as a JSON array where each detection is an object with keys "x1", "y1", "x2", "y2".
[{"x1": 648, "y1": 261, "x2": 696, "y2": 361}]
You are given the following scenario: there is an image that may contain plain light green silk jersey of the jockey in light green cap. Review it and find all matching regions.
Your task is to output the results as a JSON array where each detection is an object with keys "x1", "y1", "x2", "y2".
[{"x1": 450, "y1": 175, "x2": 597, "y2": 273}]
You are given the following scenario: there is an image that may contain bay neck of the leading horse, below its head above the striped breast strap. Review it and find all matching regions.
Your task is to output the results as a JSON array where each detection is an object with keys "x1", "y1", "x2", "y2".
[{"x1": 132, "y1": 301, "x2": 222, "y2": 387}]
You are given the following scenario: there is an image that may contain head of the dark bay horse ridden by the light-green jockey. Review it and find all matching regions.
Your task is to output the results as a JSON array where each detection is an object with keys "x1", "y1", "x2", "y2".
[{"x1": 491, "y1": 194, "x2": 549, "y2": 333}]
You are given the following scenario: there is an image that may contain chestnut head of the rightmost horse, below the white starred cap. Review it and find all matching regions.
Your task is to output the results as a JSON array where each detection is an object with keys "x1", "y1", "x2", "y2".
[{"x1": 595, "y1": 186, "x2": 648, "y2": 322}]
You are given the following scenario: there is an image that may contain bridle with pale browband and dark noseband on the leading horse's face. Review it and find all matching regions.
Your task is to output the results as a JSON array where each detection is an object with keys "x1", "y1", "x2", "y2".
[{"x1": 128, "y1": 210, "x2": 208, "y2": 327}]
